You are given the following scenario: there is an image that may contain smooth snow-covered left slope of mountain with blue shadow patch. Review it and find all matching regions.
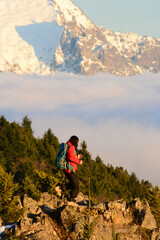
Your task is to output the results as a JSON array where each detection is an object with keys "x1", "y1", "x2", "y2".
[{"x1": 0, "y1": 0, "x2": 64, "y2": 74}]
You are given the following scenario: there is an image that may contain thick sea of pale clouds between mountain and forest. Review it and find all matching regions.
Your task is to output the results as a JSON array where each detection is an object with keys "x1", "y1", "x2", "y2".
[{"x1": 0, "y1": 73, "x2": 160, "y2": 186}]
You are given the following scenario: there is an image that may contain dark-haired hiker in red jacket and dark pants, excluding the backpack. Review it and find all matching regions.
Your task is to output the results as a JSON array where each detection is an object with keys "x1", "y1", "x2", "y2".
[{"x1": 64, "y1": 136, "x2": 83, "y2": 202}]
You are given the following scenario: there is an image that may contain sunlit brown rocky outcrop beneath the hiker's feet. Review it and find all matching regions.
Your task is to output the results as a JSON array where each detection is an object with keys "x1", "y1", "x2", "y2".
[{"x1": 1, "y1": 193, "x2": 160, "y2": 240}]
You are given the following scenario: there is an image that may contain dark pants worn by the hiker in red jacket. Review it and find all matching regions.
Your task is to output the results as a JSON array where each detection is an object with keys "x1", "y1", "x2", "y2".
[{"x1": 65, "y1": 172, "x2": 79, "y2": 198}]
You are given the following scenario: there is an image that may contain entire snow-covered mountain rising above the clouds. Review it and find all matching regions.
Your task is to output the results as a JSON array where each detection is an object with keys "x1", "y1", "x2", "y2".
[{"x1": 0, "y1": 0, "x2": 160, "y2": 76}]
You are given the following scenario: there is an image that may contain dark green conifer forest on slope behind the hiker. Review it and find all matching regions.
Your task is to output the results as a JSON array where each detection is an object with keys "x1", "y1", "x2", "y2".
[{"x1": 0, "y1": 116, "x2": 160, "y2": 227}]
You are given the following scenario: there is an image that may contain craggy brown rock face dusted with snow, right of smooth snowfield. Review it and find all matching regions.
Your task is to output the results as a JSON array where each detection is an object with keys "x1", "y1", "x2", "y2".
[{"x1": 50, "y1": 0, "x2": 160, "y2": 76}]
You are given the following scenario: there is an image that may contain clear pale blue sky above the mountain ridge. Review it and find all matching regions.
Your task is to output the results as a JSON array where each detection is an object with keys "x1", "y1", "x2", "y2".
[{"x1": 72, "y1": 0, "x2": 160, "y2": 38}]
